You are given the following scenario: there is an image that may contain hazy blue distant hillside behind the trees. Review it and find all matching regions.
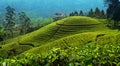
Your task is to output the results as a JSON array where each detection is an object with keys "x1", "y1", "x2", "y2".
[{"x1": 0, "y1": 0, "x2": 105, "y2": 17}]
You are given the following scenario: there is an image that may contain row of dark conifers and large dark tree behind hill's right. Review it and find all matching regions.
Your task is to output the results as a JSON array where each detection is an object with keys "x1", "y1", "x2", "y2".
[{"x1": 69, "y1": 0, "x2": 120, "y2": 29}]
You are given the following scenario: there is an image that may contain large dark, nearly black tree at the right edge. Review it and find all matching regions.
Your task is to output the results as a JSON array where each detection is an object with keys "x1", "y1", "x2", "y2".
[{"x1": 104, "y1": 0, "x2": 120, "y2": 27}]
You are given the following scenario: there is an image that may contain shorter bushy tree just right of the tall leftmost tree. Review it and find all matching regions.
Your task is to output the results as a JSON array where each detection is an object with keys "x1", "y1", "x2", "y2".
[{"x1": 18, "y1": 12, "x2": 31, "y2": 34}]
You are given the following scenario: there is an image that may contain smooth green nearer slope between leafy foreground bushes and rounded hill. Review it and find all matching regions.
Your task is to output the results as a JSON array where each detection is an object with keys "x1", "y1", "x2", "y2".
[{"x1": 25, "y1": 30, "x2": 120, "y2": 54}]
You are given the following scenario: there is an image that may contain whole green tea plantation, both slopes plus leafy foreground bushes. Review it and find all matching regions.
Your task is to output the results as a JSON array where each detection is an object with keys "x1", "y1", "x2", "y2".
[{"x1": 0, "y1": 16, "x2": 120, "y2": 66}]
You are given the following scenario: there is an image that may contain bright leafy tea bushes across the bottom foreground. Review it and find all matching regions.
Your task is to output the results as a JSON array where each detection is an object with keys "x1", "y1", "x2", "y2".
[{"x1": 0, "y1": 44, "x2": 120, "y2": 66}]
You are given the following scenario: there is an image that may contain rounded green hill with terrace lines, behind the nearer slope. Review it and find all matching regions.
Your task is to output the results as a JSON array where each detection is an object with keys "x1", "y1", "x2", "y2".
[{"x1": 0, "y1": 16, "x2": 107, "y2": 56}]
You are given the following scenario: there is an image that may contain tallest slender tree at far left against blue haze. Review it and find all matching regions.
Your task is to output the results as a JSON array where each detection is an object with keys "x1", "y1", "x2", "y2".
[{"x1": 5, "y1": 6, "x2": 15, "y2": 38}]
